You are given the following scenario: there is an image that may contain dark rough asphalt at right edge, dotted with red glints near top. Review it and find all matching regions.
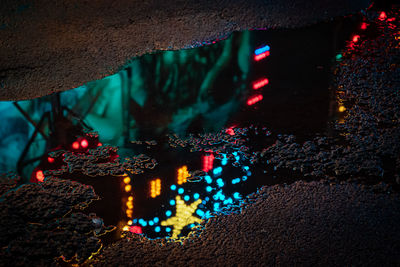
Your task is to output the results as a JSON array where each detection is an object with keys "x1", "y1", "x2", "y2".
[{"x1": 262, "y1": 10, "x2": 400, "y2": 184}]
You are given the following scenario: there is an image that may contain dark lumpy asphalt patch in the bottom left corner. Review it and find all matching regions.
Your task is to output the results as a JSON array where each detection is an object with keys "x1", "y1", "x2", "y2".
[{"x1": 0, "y1": 175, "x2": 108, "y2": 266}]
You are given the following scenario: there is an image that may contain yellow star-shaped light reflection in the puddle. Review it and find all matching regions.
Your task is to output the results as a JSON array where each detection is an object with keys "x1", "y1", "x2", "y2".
[{"x1": 161, "y1": 196, "x2": 202, "y2": 238}]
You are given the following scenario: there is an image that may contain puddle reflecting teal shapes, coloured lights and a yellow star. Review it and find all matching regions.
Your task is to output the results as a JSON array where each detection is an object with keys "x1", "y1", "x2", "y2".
[{"x1": 0, "y1": 18, "x2": 370, "y2": 243}]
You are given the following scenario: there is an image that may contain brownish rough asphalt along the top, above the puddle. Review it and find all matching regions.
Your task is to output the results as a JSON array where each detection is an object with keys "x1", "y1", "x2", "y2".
[{"x1": 0, "y1": 0, "x2": 369, "y2": 100}]
